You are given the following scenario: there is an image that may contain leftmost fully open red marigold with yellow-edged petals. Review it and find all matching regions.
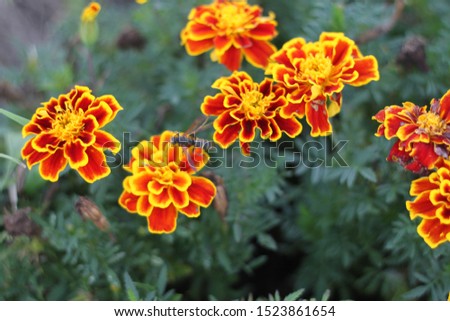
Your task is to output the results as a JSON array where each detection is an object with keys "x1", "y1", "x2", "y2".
[{"x1": 22, "y1": 86, "x2": 123, "y2": 183}]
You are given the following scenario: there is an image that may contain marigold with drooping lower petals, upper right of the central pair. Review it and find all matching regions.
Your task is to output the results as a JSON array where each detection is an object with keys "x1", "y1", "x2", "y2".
[{"x1": 266, "y1": 32, "x2": 379, "y2": 136}]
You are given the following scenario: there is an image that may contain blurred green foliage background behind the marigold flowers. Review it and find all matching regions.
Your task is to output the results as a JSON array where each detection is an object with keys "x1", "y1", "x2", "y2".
[{"x1": 0, "y1": 0, "x2": 450, "y2": 300}]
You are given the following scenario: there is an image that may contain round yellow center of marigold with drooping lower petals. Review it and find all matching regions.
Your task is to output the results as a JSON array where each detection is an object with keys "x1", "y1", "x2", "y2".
[{"x1": 300, "y1": 54, "x2": 333, "y2": 84}]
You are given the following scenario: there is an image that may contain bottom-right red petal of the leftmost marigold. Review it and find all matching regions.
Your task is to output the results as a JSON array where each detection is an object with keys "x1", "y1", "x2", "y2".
[{"x1": 77, "y1": 147, "x2": 111, "y2": 183}]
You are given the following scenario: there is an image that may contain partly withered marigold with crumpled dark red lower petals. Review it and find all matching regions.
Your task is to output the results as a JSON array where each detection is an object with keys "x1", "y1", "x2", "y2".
[{"x1": 372, "y1": 90, "x2": 450, "y2": 173}]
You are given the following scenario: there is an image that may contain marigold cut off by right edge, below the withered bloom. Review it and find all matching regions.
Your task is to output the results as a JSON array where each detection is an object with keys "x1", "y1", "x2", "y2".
[{"x1": 406, "y1": 159, "x2": 450, "y2": 248}]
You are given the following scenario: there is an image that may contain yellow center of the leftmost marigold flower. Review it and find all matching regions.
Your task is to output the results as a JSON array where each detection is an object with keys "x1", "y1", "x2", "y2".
[{"x1": 53, "y1": 102, "x2": 84, "y2": 141}]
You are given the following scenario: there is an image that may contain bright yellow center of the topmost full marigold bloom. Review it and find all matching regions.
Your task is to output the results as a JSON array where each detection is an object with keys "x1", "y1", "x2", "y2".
[{"x1": 217, "y1": 2, "x2": 253, "y2": 36}]
